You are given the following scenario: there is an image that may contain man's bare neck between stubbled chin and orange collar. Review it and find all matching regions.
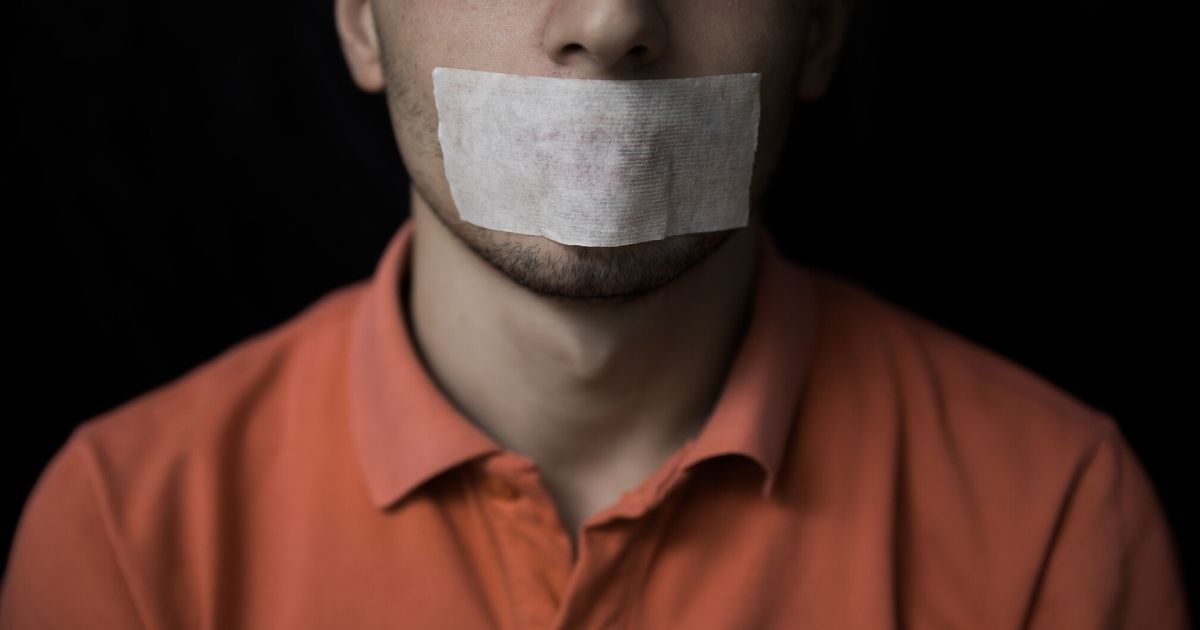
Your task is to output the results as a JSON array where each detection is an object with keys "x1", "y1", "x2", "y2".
[{"x1": 406, "y1": 189, "x2": 757, "y2": 486}]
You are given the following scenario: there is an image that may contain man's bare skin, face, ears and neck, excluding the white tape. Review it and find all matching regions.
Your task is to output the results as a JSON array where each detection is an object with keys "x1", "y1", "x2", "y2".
[{"x1": 335, "y1": 0, "x2": 851, "y2": 549}]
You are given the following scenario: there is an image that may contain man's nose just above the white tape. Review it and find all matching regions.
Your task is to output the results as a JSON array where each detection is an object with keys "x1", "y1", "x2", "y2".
[{"x1": 544, "y1": 0, "x2": 667, "y2": 73}]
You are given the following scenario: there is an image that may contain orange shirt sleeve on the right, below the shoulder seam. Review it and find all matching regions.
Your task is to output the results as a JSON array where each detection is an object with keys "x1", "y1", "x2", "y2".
[{"x1": 1028, "y1": 418, "x2": 1188, "y2": 630}]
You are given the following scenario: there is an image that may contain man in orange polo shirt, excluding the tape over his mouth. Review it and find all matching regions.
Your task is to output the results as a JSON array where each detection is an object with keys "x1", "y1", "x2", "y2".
[{"x1": 0, "y1": 0, "x2": 1187, "y2": 629}]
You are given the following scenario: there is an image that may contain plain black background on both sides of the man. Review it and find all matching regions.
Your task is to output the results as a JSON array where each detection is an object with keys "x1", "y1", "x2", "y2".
[{"x1": 0, "y1": 0, "x2": 1200, "y2": 610}]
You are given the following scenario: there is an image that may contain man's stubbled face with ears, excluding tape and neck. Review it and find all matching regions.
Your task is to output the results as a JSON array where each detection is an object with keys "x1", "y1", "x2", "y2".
[{"x1": 338, "y1": 0, "x2": 844, "y2": 299}]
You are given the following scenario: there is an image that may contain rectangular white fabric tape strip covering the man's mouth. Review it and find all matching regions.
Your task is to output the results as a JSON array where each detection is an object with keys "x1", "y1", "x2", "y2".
[{"x1": 433, "y1": 67, "x2": 761, "y2": 247}]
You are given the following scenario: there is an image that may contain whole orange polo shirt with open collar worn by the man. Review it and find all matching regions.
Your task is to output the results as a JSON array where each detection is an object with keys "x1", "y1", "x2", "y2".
[{"x1": 0, "y1": 217, "x2": 1187, "y2": 630}]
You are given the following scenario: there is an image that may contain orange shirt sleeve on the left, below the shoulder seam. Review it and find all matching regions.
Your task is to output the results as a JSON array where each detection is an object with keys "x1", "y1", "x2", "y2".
[{"x1": 0, "y1": 436, "x2": 143, "y2": 630}]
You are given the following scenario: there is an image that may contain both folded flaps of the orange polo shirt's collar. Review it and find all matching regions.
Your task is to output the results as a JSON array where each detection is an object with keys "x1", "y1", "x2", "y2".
[{"x1": 348, "y1": 221, "x2": 815, "y2": 509}]
